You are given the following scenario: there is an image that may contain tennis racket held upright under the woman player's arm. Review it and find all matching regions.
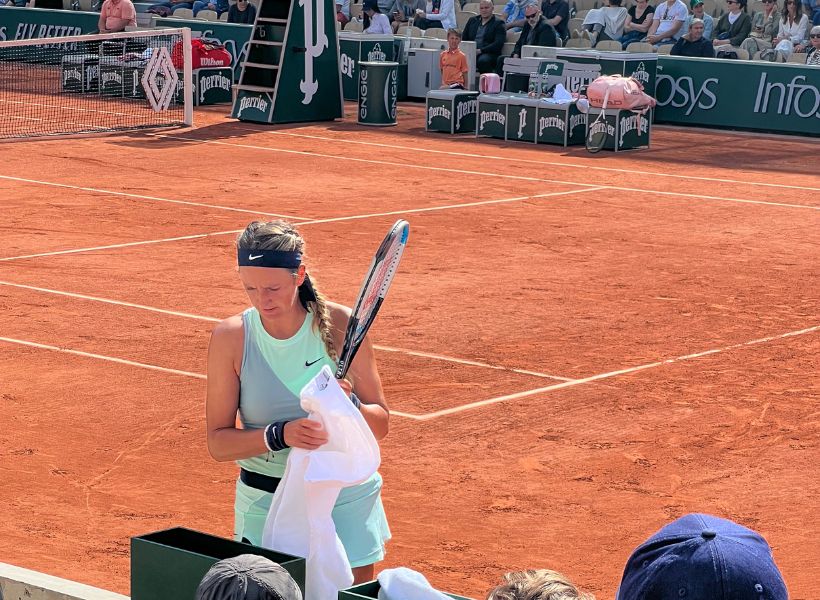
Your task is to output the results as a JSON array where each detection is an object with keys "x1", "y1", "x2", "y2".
[{"x1": 336, "y1": 219, "x2": 410, "y2": 379}]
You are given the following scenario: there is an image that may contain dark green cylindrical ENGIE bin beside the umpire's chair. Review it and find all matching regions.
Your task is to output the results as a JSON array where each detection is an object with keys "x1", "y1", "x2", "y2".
[{"x1": 357, "y1": 62, "x2": 399, "y2": 127}]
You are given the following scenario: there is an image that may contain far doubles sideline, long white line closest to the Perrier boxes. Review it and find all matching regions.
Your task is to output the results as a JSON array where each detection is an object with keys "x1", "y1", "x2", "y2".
[{"x1": 245, "y1": 127, "x2": 820, "y2": 192}]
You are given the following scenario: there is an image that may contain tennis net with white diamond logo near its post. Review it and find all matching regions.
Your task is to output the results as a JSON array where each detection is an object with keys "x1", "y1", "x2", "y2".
[{"x1": 0, "y1": 29, "x2": 193, "y2": 139}]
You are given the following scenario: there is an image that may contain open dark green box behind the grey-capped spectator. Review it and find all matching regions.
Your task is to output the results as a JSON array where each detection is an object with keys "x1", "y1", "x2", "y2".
[{"x1": 131, "y1": 527, "x2": 305, "y2": 600}]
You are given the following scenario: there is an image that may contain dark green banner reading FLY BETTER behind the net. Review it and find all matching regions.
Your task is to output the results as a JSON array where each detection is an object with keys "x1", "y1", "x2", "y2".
[{"x1": 0, "y1": 6, "x2": 100, "y2": 42}]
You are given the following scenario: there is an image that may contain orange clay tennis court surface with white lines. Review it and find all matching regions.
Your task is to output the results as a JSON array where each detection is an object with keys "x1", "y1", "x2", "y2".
[{"x1": 0, "y1": 104, "x2": 820, "y2": 600}]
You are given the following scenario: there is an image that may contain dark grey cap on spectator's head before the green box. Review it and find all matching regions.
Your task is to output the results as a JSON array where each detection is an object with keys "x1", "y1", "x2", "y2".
[{"x1": 196, "y1": 554, "x2": 302, "y2": 600}]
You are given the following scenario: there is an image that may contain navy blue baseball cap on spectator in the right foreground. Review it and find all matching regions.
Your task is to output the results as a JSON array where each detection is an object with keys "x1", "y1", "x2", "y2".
[{"x1": 616, "y1": 514, "x2": 788, "y2": 600}]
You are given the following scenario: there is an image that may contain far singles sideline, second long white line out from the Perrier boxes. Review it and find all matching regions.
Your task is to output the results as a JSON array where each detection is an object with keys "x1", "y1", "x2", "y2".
[{"x1": 152, "y1": 133, "x2": 820, "y2": 211}]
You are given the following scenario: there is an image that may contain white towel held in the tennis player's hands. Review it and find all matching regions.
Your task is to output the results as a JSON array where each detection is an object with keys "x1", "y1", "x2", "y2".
[{"x1": 262, "y1": 366, "x2": 381, "y2": 600}]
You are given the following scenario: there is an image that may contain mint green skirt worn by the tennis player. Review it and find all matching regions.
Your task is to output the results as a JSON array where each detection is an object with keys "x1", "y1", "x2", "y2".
[{"x1": 234, "y1": 473, "x2": 390, "y2": 568}]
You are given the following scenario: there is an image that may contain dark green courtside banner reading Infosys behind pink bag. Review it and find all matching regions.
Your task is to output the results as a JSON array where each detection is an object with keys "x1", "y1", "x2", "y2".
[{"x1": 655, "y1": 56, "x2": 820, "y2": 135}]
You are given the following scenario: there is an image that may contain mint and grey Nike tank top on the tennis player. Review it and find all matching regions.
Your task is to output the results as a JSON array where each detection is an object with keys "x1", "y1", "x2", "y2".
[{"x1": 237, "y1": 308, "x2": 336, "y2": 477}]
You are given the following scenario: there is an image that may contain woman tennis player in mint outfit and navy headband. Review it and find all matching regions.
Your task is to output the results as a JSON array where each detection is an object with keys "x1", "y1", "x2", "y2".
[{"x1": 206, "y1": 221, "x2": 390, "y2": 583}]
